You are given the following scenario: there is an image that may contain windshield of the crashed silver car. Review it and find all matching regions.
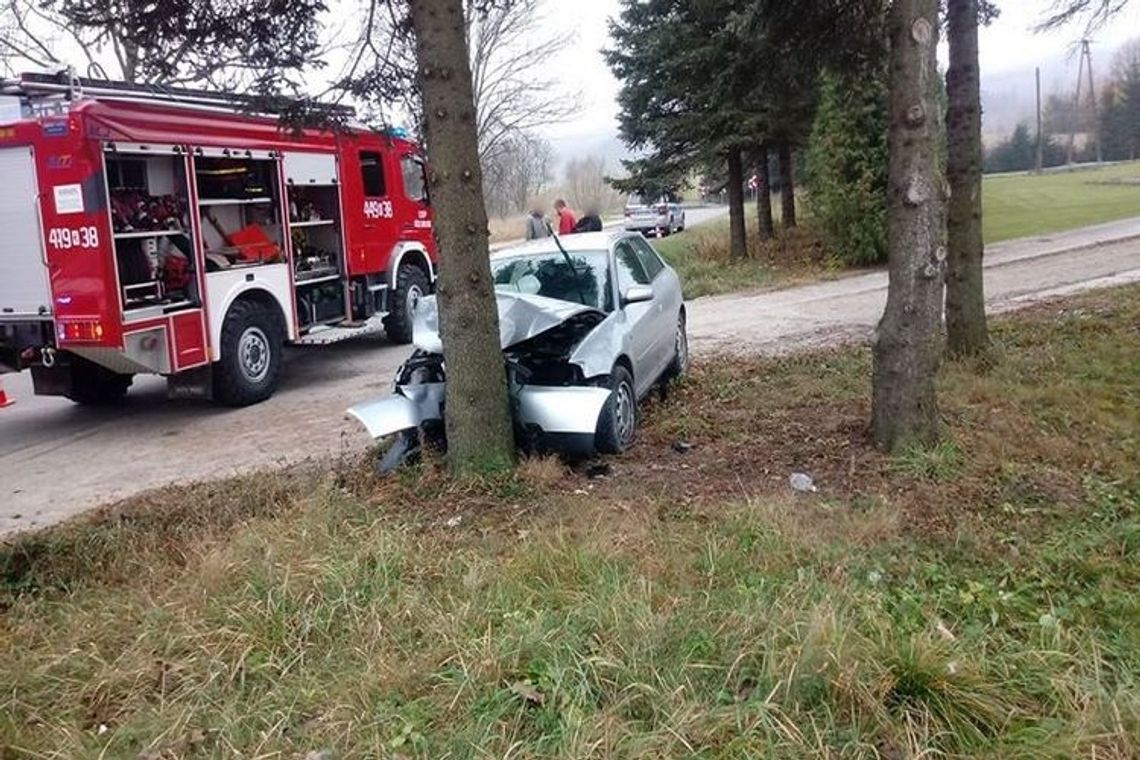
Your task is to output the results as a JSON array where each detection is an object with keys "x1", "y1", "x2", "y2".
[{"x1": 491, "y1": 251, "x2": 613, "y2": 311}]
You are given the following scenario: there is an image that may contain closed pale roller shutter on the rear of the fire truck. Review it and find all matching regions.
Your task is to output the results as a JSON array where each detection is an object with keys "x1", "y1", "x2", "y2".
[{"x1": 0, "y1": 146, "x2": 51, "y2": 321}]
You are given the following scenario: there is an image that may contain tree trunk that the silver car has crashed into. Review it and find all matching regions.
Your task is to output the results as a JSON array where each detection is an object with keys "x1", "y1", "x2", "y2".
[{"x1": 410, "y1": 0, "x2": 514, "y2": 475}]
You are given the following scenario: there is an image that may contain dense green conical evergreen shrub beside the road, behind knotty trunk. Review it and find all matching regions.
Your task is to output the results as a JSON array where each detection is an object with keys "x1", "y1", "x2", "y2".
[{"x1": 807, "y1": 67, "x2": 888, "y2": 265}]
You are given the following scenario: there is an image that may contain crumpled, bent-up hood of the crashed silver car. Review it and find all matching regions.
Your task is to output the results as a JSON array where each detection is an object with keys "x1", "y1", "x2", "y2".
[{"x1": 412, "y1": 291, "x2": 605, "y2": 353}]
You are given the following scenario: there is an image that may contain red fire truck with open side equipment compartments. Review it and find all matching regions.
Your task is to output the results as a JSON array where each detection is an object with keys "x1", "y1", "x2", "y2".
[{"x1": 0, "y1": 74, "x2": 437, "y2": 406}]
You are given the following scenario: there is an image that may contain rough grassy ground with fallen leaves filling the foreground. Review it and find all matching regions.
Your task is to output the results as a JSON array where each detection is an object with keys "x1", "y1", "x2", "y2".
[{"x1": 0, "y1": 287, "x2": 1140, "y2": 760}]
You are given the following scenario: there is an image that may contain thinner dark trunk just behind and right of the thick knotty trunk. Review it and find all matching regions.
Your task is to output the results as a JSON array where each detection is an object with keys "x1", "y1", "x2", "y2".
[{"x1": 946, "y1": 0, "x2": 990, "y2": 356}]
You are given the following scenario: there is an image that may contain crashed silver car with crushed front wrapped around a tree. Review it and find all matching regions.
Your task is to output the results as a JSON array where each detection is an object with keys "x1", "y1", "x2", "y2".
[{"x1": 349, "y1": 232, "x2": 689, "y2": 469}]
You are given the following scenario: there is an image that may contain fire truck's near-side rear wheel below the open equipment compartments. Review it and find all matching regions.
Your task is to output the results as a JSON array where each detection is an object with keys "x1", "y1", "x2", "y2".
[{"x1": 213, "y1": 300, "x2": 285, "y2": 407}]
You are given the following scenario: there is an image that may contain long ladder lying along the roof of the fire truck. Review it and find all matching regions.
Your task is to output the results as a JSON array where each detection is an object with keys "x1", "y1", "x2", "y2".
[{"x1": 0, "y1": 70, "x2": 356, "y2": 119}]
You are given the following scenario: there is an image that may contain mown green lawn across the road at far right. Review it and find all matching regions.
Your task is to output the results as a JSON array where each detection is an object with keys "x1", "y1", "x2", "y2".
[{"x1": 983, "y1": 163, "x2": 1140, "y2": 243}]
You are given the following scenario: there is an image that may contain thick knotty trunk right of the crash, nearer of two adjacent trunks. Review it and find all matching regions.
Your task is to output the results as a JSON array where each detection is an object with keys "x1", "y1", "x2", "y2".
[{"x1": 871, "y1": 0, "x2": 946, "y2": 449}]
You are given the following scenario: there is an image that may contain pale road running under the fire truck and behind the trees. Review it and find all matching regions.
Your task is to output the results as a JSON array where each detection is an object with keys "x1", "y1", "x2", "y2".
[{"x1": 0, "y1": 210, "x2": 1140, "y2": 534}]
